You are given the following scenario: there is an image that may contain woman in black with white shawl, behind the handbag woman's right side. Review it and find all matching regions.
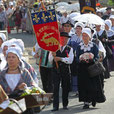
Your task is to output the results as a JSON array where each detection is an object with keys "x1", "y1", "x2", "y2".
[{"x1": 93, "y1": 25, "x2": 110, "y2": 79}]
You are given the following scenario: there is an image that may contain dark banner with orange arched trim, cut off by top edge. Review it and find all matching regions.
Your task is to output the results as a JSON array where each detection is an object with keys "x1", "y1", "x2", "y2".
[{"x1": 79, "y1": 0, "x2": 96, "y2": 13}]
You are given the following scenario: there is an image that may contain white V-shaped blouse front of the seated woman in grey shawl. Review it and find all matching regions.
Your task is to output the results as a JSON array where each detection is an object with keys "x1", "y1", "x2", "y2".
[{"x1": 5, "y1": 74, "x2": 21, "y2": 91}]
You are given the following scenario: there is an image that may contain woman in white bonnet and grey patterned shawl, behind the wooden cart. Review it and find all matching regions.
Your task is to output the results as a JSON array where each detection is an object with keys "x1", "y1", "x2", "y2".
[{"x1": 0, "y1": 47, "x2": 36, "y2": 97}]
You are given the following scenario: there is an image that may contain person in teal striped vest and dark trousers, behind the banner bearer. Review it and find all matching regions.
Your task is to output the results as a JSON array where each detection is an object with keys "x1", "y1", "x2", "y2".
[{"x1": 32, "y1": 43, "x2": 53, "y2": 93}]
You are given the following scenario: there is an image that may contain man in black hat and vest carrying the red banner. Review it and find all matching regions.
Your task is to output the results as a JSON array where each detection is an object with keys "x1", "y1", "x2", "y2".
[{"x1": 49, "y1": 32, "x2": 74, "y2": 111}]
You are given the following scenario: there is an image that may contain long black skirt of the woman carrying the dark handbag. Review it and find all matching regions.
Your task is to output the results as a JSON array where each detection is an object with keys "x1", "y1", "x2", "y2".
[{"x1": 78, "y1": 63, "x2": 106, "y2": 103}]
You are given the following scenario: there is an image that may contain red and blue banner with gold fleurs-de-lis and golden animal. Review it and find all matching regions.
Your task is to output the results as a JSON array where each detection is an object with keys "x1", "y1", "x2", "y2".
[{"x1": 31, "y1": 9, "x2": 59, "y2": 52}]
